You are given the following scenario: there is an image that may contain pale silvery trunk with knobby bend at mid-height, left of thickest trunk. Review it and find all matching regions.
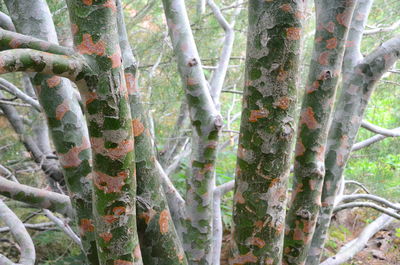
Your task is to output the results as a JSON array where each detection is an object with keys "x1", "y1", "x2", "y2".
[{"x1": 163, "y1": 0, "x2": 222, "y2": 265}]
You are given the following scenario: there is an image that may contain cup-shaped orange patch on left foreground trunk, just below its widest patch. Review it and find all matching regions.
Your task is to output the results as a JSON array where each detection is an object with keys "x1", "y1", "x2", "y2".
[{"x1": 93, "y1": 171, "x2": 128, "y2": 193}]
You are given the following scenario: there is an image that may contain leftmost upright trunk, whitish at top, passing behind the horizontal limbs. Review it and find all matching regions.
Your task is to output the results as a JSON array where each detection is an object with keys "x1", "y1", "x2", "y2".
[{"x1": 2, "y1": 0, "x2": 98, "y2": 264}]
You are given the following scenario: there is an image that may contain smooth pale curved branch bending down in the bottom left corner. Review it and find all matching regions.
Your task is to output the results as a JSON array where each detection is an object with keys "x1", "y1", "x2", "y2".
[{"x1": 0, "y1": 199, "x2": 36, "y2": 265}]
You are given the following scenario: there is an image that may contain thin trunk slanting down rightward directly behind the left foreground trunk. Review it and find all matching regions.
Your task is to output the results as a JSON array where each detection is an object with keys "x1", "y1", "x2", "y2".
[{"x1": 117, "y1": 0, "x2": 187, "y2": 265}]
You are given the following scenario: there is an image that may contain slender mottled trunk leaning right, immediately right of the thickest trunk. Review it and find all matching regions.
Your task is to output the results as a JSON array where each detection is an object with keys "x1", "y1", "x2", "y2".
[{"x1": 283, "y1": 0, "x2": 356, "y2": 265}]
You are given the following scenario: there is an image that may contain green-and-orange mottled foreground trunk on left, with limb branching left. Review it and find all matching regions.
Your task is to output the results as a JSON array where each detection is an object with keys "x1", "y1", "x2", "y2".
[{"x1": 67, "y1": 0, "x2": 142, "y2": 265}]
